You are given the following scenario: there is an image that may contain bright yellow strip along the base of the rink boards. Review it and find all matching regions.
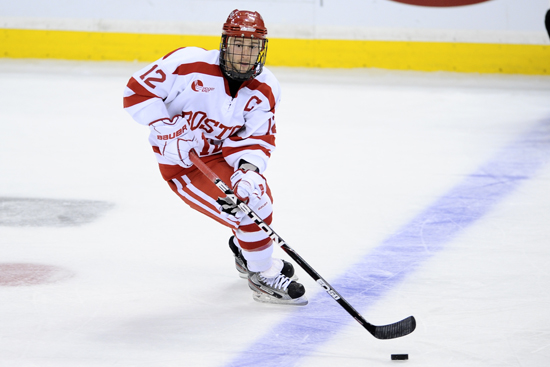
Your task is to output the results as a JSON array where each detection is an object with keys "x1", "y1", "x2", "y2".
[{"x1": 0, "y1": 29, "x2": 550, "y2": 75}]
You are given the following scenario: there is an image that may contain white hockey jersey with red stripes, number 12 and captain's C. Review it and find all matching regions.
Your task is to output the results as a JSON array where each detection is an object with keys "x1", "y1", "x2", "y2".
[{"x1": 124, "y1": 47, "x2": 280, "y2": 180}]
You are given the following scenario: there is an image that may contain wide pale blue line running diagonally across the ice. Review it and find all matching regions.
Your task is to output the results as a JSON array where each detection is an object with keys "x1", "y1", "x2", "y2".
[{"x1": 222, "y1": 121, "x2": 550, "y2": 367}]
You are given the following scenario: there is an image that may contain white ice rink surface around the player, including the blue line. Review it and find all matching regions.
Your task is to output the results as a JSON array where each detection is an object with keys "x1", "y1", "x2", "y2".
[{"x1": 0, "y1": 59, "x2": 550, "y2": 367}]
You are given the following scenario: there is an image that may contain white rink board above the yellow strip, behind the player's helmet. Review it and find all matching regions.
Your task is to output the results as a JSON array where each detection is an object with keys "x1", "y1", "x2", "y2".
[{"x1": 0, "y1": 0, "x2": 550, "y2": 44}]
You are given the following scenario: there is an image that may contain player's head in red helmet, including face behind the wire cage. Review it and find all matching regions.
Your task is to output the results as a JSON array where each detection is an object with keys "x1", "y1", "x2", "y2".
[{"x1": 220, "y1": 9, "x2": 267, "y2": 81}]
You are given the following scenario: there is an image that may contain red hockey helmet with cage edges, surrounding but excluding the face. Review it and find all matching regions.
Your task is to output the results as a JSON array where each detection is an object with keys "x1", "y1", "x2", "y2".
[{"x1": 220, "y1": 9, "x2": 267, "y2": 81}]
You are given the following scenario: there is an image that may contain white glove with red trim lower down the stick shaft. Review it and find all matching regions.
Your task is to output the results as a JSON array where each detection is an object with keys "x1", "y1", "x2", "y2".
[{"x1": 231, "y1": 163, "x2": 267, "y2": 203}]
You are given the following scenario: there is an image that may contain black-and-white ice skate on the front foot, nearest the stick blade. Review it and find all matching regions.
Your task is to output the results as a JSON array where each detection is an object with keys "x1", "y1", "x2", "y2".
[{"x1": 248, "y1": 259, "x2": 308, "y2": 306}]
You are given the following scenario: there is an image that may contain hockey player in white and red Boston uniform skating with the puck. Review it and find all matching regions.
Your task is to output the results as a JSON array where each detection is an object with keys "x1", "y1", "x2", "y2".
[{"x1": 124, "y1": 10, "x2": 307, "y2": 305}]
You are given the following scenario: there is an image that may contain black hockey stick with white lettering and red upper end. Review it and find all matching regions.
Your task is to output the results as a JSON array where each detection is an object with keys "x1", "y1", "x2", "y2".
[{"x1": 189, "y1": 151, "x2": 416, "y2": 339}]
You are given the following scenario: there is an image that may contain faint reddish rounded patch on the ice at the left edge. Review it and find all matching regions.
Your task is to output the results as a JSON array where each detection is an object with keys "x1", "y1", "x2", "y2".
[{"x1": 0, "y1": 263, "x2": 74, "y2": 287}]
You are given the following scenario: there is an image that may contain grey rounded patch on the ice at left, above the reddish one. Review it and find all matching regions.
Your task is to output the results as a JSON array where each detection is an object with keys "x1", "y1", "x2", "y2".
[{"x1": 0, "y1": 197, "x2": 114, "y2": 227}]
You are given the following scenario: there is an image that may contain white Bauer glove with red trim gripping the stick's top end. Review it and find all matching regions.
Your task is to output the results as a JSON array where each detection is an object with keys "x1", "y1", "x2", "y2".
[{"x1": 149, "y1": 115, "x2": 205, "y2": 168}]
